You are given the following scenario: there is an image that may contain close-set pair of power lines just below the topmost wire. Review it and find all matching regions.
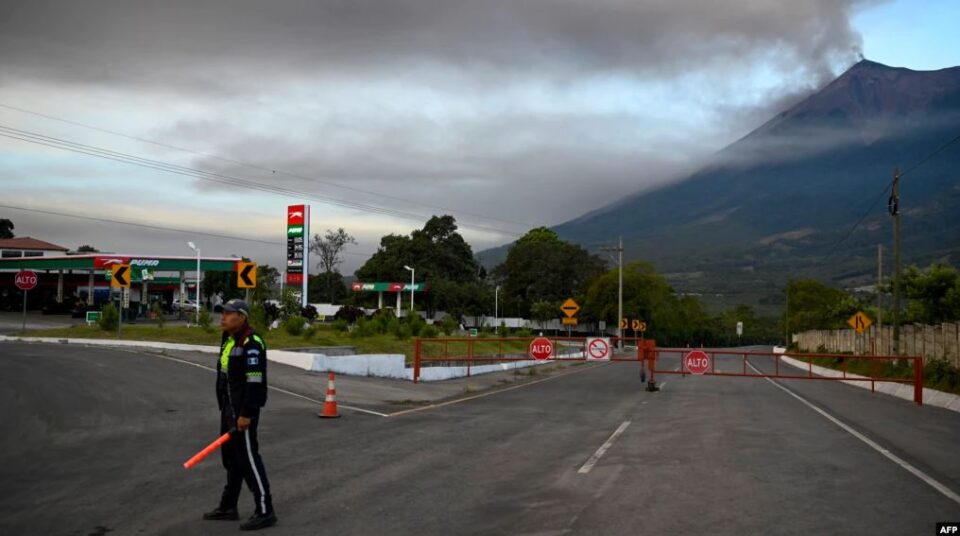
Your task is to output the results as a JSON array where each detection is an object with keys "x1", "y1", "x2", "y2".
[{"x1": 0, "y1": 124, "x2": 520, "y2": 236}]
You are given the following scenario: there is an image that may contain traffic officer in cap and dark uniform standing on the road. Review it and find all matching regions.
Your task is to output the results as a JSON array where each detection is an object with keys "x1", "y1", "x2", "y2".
[{"x1": 203, "y1": 300, "x2": 277, "y2": 530}]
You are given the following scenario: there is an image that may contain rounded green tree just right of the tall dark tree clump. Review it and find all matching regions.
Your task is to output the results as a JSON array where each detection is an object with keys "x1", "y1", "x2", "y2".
[{"x1": 494, "y1": 227, "x2": 604, "y2": 317}]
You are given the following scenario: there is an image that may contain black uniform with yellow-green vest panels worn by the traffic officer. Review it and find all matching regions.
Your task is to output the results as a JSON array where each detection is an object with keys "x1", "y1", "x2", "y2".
[{"x1": 217, "y1": 326, "x2": 273, "y2": 515}]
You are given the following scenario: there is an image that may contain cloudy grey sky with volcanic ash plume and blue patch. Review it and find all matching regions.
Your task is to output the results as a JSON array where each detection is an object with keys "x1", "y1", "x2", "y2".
[{"x1": 0, "y1": 0, "x2": 960, "y2": 273}]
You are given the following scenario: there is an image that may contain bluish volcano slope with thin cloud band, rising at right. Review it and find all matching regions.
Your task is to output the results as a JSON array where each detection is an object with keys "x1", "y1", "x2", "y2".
[{"x1": 489, "y1": 61, "x2": 960, "y2": 312}]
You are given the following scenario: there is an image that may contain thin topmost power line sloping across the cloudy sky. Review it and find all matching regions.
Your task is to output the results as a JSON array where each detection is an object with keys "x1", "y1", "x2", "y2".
[{"x1": 0, "y1": 102, "x2": 534, "y2": 228}]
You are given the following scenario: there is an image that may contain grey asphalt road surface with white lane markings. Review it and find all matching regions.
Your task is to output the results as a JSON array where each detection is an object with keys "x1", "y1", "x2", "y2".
[{"x1": 0, "y1": 343, "x2": 960, "y2": 535}]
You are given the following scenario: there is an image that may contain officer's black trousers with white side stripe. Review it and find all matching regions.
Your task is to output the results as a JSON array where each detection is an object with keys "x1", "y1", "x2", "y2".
[{"x1": 220, "y1": 406, "x2": 273, "y2": 514}]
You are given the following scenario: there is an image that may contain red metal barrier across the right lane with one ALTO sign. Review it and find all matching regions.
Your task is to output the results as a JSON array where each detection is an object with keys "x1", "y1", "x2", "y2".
[{"x1": 650, "y1": 348, "x2": 923, "y2": 405}]
